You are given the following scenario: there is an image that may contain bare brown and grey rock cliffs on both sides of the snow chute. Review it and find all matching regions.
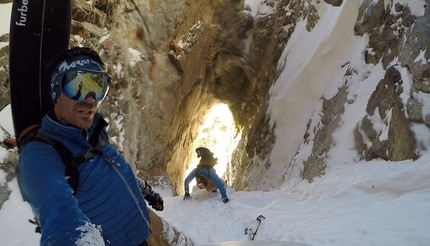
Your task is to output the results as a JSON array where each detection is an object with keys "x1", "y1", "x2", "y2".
[{"x1": 0, "y1": 0, "x2": 430, "y2": 202}]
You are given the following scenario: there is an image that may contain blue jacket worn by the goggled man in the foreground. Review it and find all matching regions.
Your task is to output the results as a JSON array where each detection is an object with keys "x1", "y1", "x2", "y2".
[{"x1": 17, "y1": 113, "x2": 150, "y2": 246}]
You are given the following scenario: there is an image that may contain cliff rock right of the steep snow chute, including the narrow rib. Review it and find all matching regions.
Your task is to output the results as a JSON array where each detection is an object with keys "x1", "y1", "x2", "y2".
[{"x1": 296, "y1": 0, "x2": 430, "y2": 181}]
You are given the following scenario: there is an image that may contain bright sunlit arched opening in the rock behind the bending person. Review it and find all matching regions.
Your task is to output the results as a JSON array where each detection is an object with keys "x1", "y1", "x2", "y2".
[{"x1": 186, "y1": 104, "x2": 241, "y2": 187}]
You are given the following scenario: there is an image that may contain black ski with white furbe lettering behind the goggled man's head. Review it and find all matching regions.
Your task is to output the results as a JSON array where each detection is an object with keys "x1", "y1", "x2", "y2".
[{"x1": 9, "y1": 0, "x2": 71, "y2": 139}]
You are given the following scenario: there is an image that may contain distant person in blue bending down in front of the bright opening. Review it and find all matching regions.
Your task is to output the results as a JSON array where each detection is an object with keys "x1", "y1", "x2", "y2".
[{"x1": 184, "y1": 147, "x2": 229, "y2": 203}]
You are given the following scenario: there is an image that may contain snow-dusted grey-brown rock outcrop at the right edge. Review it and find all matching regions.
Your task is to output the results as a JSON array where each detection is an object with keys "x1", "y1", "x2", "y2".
[{"x1": 355, "y1": 1, "x2": 430, "y2": 161}]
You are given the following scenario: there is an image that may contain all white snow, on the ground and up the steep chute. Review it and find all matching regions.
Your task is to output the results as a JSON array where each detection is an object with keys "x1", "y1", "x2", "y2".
[{"x1": 0, "y1": 0, "x2": 430, "y2": 246}]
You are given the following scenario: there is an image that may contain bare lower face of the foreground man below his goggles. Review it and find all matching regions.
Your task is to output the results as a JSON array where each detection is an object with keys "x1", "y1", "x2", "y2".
[{"x1": 54, "y1": 92, "x2": 97, "y2": 130}]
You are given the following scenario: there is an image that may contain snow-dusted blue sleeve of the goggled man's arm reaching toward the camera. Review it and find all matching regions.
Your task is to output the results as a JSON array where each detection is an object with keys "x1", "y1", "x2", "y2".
[{"x1": 17, "y1": 142, "x2": 104, "y2": 245}]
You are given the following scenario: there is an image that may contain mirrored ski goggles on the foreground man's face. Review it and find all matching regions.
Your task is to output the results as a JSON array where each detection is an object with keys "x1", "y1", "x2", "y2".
[{"x1": 62, "y1": 70, "x2": 110, "y2": 101}]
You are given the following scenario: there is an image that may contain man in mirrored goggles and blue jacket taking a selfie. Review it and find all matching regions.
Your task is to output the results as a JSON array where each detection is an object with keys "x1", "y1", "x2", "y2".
[{"x1": 17, "y1": 47, "x2": 164, "y2": 246}]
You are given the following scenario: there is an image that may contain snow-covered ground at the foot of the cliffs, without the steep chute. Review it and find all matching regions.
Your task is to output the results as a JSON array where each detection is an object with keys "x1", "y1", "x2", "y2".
[{"x1": 0, "y1": 145, "x2": 430, "y2": 246}]
